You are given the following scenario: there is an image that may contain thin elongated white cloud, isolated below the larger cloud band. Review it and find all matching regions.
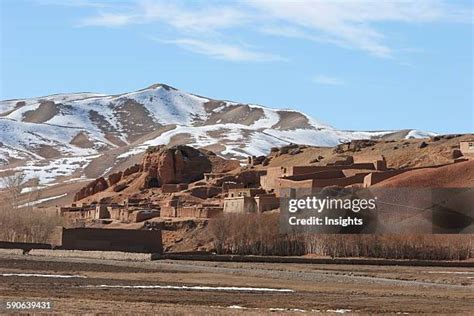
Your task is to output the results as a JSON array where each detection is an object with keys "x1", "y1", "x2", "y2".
[{"x1": 157, "y1": 38, "x2": 284, "y2": 62}]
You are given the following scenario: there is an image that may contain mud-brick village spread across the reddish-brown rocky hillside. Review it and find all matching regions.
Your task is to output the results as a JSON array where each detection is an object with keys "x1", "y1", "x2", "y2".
[{"x1": 49, "y1": 135, "x2": 474, "y2": 250}]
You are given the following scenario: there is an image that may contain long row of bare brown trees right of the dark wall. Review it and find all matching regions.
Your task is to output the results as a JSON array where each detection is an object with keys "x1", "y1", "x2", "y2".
[{"x1": 210, "y1": 213, "x2": 474, "y2": 260}]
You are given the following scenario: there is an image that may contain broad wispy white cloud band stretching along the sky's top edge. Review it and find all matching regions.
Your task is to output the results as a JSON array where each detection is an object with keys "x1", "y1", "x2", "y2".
[{"x1": 68, "y1": 0, "x2": 472, "y2": 60}]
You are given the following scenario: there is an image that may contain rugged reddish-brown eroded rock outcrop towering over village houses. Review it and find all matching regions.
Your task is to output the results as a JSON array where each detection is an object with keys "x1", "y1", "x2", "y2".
[{"x1": 74, "y1": 145, "x2": 240, "y2": 201}]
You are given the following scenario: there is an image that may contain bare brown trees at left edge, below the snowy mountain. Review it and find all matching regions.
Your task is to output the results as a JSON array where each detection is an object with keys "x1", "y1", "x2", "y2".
[{"x1": 0, "y1": 172, "x2": 62, "y2": 242}]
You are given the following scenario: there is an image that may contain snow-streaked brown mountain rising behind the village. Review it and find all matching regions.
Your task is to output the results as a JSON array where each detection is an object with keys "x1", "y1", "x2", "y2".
[{"x1": 0, "y1": 84, "x2": 433, "y2": 189}]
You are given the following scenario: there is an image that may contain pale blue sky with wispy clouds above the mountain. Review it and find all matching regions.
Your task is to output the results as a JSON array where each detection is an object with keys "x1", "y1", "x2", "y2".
[{"x1": 0, "y1": 0, "x2": 474, "y2": 133}]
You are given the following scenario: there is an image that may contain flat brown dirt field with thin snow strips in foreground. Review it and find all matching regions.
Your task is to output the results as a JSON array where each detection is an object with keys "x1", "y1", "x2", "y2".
[{"x1": 0, "y1": 250, "x2": 474, "y2": 315}]
